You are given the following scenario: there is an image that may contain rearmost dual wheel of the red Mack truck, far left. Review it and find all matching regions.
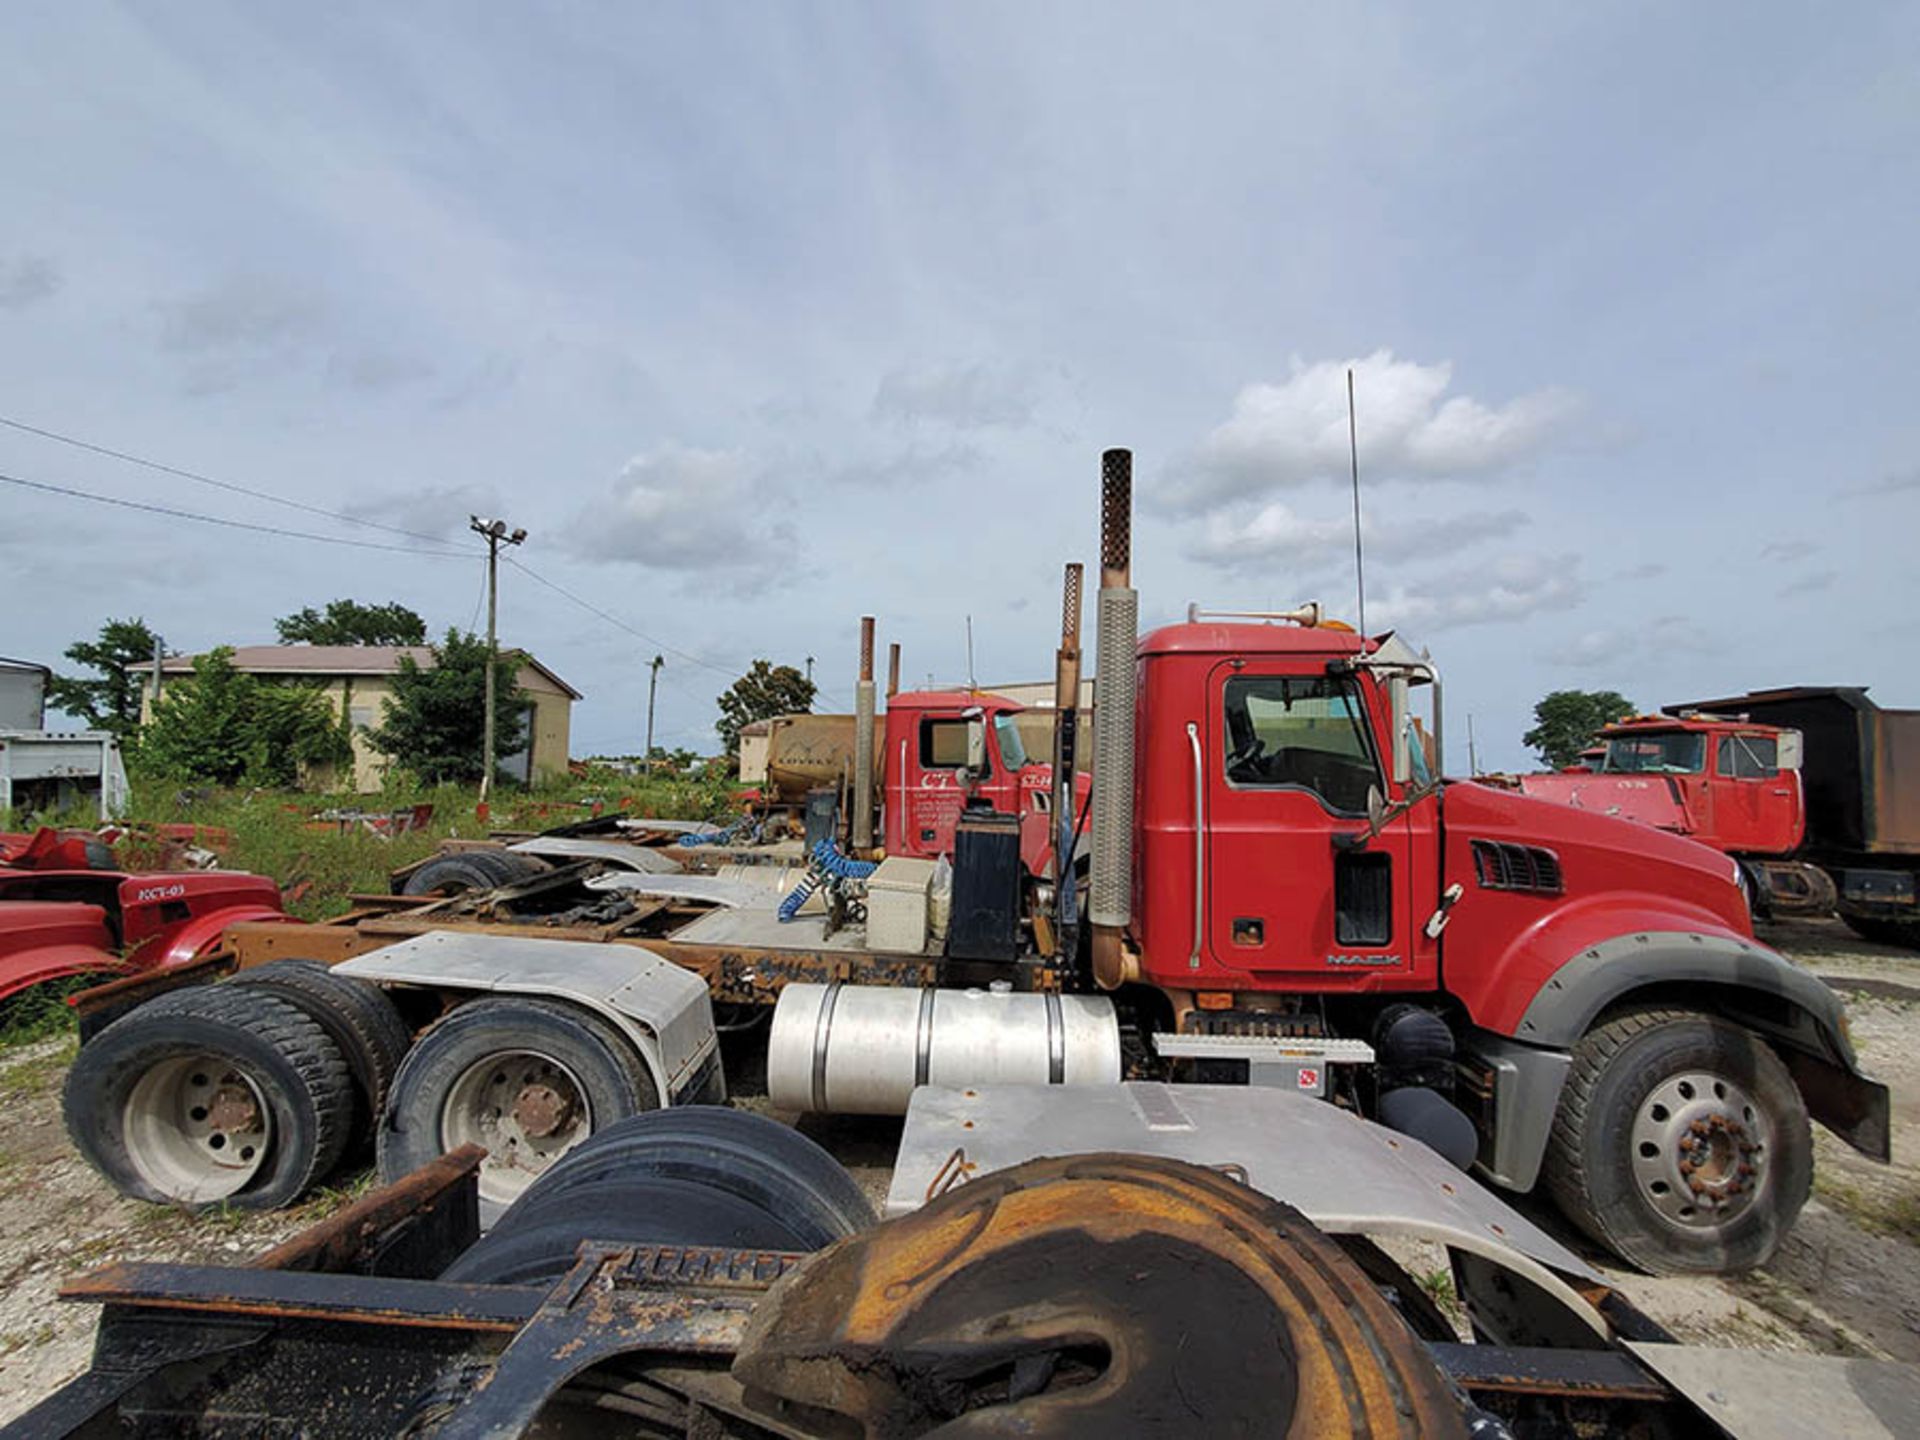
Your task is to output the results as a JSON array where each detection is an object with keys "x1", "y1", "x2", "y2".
[{"x1": 61, "y1": 985, "x2": 353, "y2": 1210}]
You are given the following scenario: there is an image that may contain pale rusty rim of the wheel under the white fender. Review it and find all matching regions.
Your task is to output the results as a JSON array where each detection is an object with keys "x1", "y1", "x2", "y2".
[{"x1": 440, "y1": 1050, "x2": 593, "y2": 1206}]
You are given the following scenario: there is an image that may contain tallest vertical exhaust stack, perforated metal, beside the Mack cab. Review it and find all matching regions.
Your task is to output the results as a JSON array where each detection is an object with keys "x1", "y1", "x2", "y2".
[{"x1": 1087, "y1": 449, "x2": 1140, "y2": 989}]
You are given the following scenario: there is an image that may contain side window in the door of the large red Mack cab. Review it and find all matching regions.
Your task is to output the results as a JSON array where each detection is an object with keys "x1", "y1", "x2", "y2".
[{"x1": 1223, "y1": 676, "x2": 1380, "y2": 814}]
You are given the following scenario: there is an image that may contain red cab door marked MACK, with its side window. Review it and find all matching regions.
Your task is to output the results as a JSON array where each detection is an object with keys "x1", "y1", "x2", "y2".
[{"x1": 1200, "y1": 660, "x2": 1434, "y2": 991}]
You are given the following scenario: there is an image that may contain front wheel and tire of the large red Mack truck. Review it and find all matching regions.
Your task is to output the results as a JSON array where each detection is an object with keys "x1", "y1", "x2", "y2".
[{"x1": 1544, "y1": 1010, "x2": 1812, "y2": 1275}]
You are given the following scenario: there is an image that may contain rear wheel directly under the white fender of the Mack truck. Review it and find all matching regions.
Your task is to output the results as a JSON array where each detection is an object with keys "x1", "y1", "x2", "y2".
[{"x1": 378, "y1": 996, "x2": 660, "y2": 1225}]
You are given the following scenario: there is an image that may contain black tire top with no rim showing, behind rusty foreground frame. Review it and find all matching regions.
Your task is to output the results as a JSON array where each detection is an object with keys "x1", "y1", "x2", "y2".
[{"x1": 444, "y1": 1106, "x2": 874, "y2": 1284}]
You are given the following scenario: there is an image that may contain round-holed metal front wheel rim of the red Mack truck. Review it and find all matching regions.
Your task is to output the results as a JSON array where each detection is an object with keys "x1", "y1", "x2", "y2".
[{"x1": 1630, "y1": 1069, "x2": 1774, "y2": 1231}]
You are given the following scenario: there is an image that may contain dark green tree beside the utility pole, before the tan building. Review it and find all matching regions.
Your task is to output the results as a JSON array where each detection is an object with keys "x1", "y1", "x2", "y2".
[{"x1": 367, "y1": 630, "x2": 526, "y2": 785}]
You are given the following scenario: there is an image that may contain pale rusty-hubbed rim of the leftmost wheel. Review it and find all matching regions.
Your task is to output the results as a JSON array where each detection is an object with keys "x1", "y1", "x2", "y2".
[{"x1": 121, "y1": 1054, "x2": 273, "y2": 1206}]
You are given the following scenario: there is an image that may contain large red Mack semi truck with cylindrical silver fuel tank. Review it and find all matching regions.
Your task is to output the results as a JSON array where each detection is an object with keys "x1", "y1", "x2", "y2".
[{"x1": 69, "y1": 451, "x2": 1889, "y2": 1271}]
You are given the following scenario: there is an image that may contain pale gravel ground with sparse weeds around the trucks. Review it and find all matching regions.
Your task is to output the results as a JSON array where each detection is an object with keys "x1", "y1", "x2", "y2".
[{"x1": 0, "y1": 922, "x2": 1920, "y2": 1423}]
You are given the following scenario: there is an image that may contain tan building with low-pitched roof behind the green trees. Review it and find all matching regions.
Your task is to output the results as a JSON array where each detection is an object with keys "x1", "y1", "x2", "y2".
[{"x1": 142, "y1": 645, "x2": 580, "y2": 793}]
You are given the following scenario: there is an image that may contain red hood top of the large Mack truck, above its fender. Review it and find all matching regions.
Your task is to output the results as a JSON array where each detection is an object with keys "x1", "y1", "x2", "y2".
[{"x1": 1444, "y1": 776, "x2": 1753, "y2": 935}]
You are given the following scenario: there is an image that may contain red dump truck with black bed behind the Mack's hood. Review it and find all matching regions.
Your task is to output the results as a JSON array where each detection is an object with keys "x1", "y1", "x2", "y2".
[{"x1": 1515, "y1": 685, "x2": 1920, "y2": 948}]
